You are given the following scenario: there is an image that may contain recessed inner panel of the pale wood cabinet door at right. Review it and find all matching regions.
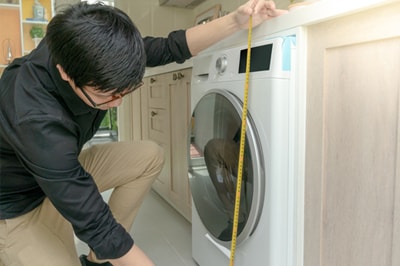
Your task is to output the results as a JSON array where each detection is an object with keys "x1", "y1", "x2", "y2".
[{"x1": 321, "y1": 38, "x2": 400, "y2": 266}]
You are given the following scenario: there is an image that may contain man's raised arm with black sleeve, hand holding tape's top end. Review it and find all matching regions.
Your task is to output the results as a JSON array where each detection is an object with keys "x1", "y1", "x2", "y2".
[{"x1": 144, "y1": 0, "x2": 287, "y2": 67}]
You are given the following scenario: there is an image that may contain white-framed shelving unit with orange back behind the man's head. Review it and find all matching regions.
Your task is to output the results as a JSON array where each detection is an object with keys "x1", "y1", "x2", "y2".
[{"x1": 0, "y1": 0, "x2": 54, "y2": 74}]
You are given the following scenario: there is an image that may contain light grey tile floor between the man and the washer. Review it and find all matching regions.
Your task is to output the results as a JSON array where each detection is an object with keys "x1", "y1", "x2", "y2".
[{"x1": 76, "y1": 191, "x2": 197, "y2": 266}]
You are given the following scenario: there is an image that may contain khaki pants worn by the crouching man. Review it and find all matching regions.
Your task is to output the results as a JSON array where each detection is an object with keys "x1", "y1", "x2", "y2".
[{"x1": 0, "y1": 141, "x2": 164, "y2": 266}]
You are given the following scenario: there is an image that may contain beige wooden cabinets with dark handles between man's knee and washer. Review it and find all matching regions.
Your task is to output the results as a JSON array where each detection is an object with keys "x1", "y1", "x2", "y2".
[{"x1": 137, "y1": 68, "x2": 191, "y2": 221}]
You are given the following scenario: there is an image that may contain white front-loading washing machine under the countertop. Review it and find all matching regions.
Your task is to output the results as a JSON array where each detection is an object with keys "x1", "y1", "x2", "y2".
[{"x1": 188, "y1": 29, "x2": 305, "y2": 266}]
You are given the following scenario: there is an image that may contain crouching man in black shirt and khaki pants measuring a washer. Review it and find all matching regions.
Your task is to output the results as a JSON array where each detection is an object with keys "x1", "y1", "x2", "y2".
[{"x1": 0, "y1": 0, "x2": 285, "y2": 266}]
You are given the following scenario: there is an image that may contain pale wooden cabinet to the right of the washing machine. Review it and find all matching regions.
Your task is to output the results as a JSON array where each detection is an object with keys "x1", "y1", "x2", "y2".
[{"x1": 304, "y1": 1, "x2": 400, "y2": 266}]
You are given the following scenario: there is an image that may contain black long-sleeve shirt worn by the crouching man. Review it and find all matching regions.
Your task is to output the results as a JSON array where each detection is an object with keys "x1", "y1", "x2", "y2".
[{"x1": 0, "y1": 31, "x2": 191, "y2": 259}]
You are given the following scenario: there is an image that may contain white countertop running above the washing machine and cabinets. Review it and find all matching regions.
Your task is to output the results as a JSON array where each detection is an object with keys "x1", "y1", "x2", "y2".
[{"x1": 145, "y1": 0, "x2": 400, "y2": 76}]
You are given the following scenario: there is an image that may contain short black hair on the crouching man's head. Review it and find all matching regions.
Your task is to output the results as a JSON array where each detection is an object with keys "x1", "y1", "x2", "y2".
[{"x1": 45, "y1": 2, "x2": 146, "y2": 93}]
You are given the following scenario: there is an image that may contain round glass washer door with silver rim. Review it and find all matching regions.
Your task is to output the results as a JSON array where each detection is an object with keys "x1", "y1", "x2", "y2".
[{"x1": 189, "y1": 90, "x2": 265, "y2": 245}]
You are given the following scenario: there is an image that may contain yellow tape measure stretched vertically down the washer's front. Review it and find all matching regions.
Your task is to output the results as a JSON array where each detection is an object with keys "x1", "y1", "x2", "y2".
[{"x1": 229, "y1": 16, "x2": 253, "y2": 266}]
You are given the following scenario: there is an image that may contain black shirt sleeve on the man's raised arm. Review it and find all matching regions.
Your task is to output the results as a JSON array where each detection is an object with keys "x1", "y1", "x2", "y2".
[{"x1": 143, "y1": 30, "x2": 192, "y2": 67}]
